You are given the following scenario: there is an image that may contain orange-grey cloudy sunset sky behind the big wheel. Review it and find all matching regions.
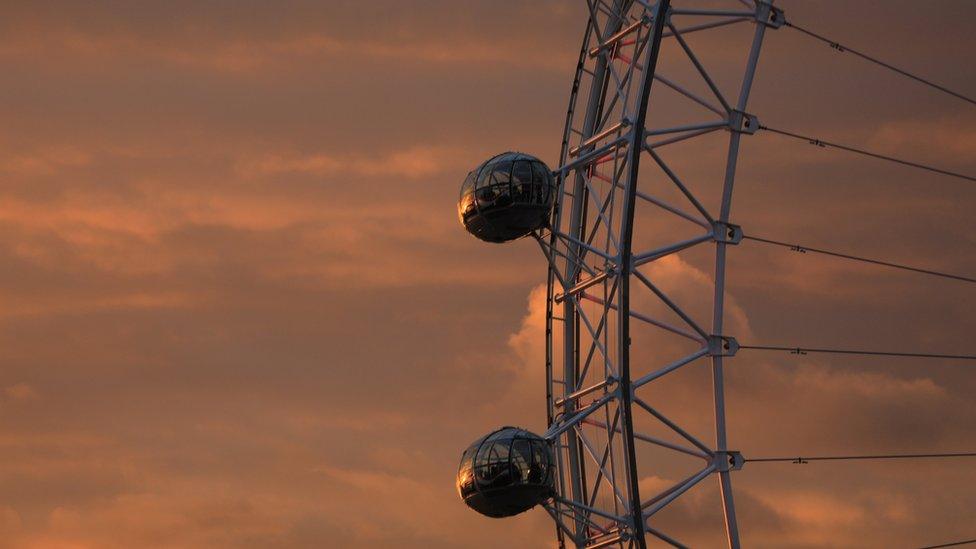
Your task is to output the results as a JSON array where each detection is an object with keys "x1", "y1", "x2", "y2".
[{"x1": 0, "y1": 0, "x2": 976, "y2": 549}]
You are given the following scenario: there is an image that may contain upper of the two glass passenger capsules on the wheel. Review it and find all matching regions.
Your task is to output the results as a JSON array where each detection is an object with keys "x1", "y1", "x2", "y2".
[{"x1": 458, "y1": 152, "x2": 556, "y2": 243}]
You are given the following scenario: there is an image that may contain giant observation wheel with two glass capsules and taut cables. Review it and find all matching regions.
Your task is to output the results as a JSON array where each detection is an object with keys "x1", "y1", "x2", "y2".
[{"x1": 458, "y1": 0, "x2": 976, "y2": 548}]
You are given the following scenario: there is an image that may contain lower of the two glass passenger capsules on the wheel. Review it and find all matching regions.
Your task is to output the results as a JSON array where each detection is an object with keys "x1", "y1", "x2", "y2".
[{"x1": 457, "y1": 427, "x2": 555, "y2": 518}]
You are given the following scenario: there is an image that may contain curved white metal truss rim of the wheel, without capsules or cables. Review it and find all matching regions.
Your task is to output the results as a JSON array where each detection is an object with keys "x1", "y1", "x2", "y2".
[{"x1": 536, "y1": 0, "x2": 783, "y2": 548}]
